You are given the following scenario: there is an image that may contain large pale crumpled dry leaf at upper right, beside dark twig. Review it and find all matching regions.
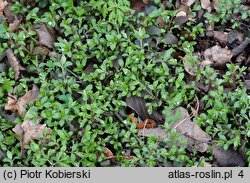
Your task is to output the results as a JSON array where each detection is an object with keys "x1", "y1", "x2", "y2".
[{"x1": 204, "y1": 45, "x2": 233, "y2": 67}]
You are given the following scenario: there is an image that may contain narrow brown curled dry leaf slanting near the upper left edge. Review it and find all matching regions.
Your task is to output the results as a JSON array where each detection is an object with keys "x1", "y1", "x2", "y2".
[{"x1": 6, "y1": 48, "x2": 25, "y2": 80}]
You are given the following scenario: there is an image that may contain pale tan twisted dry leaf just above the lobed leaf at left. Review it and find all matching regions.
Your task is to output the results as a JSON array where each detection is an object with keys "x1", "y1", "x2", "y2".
[{"x1": 5, "y1": 85, "x2": 39, "y2": 115}]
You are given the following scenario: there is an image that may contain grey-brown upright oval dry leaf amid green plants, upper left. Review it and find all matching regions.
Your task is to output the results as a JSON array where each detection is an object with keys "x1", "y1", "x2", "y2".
[{"x1": 35, "y1": 23, "x2": 55, "y2": 48}]
